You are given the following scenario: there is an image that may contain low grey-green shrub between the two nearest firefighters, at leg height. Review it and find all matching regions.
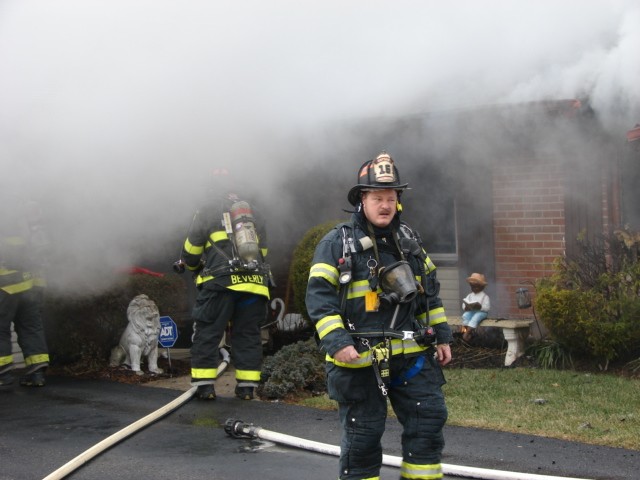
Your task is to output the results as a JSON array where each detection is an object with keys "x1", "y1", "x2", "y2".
[{"x1": 258, "y1": 339, "x2": 327, "y2": 399}]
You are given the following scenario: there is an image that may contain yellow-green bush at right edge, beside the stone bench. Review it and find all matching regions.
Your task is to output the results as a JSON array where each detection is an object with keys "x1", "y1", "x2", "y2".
[{"x1": 536, "y1": 231, "x2": 640, "y2": 363}]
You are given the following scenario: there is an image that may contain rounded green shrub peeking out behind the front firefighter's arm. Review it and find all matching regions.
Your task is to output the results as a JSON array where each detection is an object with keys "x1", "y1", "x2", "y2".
[{"x1": 289, "y1": 221, "x2": 340, "y2": 321}]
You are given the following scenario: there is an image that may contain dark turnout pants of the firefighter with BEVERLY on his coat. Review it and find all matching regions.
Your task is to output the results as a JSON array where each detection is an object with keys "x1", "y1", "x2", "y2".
[{"x1": 191, "y1": 288, "x2": 267, "y2": 385}]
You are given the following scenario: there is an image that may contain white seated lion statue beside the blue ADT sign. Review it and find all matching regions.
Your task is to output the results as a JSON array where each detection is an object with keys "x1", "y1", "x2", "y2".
[{"x1": 110, "y1": 295, "x2": 163, "y2": 375}]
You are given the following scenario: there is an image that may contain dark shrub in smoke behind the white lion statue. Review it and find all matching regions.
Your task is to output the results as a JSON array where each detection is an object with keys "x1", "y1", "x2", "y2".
[{"x1": 44, "y1": 274, "x2": 187, "y2": 370}]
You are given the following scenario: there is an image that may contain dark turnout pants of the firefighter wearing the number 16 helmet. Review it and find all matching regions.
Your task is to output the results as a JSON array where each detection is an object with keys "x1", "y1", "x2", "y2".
[{"x1": 327, "y1": 353, "x2": 447, "y2": 480}]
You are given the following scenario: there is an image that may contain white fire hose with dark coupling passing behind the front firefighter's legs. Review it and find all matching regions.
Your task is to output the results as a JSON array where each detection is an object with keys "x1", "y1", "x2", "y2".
[{"x1": 224, "y1": 418, "x2": 586, "y2": 480}]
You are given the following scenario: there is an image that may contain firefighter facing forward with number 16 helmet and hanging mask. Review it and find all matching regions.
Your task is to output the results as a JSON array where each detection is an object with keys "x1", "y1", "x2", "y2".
[{"x1": 306, "y1": 152, "x2": 452, "y2": 479}]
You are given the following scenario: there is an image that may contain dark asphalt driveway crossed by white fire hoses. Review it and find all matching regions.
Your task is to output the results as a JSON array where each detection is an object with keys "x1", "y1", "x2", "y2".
[{"x1": 0, "y1": 377, "x2": 640, "y2": 480}]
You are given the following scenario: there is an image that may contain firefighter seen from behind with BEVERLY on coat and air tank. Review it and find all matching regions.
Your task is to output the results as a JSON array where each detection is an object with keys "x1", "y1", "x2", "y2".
[{"x1": 182, "y1": 177, "x2": 270, "y2": 400}]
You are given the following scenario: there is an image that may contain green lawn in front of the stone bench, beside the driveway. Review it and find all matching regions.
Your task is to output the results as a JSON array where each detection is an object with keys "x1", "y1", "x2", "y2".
[{"x1": 303, "y1": 368, "x2": 640, "y2": 450}]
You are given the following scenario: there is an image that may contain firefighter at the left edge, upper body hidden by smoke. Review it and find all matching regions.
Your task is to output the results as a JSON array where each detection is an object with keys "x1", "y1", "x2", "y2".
[{"x1": 0, "y1": 201, "x2": 49, "y2": 390}]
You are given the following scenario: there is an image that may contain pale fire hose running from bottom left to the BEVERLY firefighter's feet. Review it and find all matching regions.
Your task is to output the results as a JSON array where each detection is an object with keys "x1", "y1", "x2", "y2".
[{"x1": 43, "y1": 348, "x2": 230, "y2": 480}]
